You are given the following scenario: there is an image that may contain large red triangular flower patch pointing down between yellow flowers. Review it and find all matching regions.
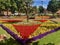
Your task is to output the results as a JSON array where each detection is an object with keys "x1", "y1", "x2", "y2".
[{"x1": 13, "y1": 25, "x2": 40, "y2": 39}]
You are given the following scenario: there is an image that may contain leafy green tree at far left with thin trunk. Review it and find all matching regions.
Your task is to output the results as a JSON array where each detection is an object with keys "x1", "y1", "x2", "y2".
[{"x1": 0, "y1": 0, "x2": 11, "y2": 15}]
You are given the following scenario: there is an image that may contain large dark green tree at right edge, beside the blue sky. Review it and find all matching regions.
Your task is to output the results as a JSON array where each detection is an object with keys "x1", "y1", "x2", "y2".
[{"x1": 47, "y1": 0, "x2": 60, "y2": 14}]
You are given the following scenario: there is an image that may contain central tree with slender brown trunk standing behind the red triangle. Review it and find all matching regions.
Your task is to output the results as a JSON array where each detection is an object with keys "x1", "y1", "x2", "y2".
[{"x1": 16, "y1": 0, "x2": 33, "y2": 22}]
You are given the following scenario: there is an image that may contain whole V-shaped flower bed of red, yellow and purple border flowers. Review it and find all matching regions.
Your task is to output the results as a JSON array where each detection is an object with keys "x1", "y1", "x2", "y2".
[{"x1": 2, "y1": 20, "x2": 60, "y2": 45}]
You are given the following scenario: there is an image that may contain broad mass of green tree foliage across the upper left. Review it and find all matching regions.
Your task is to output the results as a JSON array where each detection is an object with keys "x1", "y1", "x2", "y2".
[{"x1": 0, "y1": 0, "x2": 32, "y2": 12}]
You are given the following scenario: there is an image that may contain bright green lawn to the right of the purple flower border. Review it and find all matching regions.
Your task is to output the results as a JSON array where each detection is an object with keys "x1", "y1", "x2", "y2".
[{"x1": 38, "y1": 31, "x2": 60, "y2": 45}]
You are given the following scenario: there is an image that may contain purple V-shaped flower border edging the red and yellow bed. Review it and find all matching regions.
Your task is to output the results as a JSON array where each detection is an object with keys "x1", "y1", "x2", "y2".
[{"x1": 0, "y1": 25, "x2": 60, "y2": 45}]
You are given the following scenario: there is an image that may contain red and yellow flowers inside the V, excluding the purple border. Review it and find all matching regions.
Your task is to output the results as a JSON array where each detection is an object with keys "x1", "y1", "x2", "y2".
[{"x1": 3, "y1": 20, "x2": 59, "y2": 39}]
